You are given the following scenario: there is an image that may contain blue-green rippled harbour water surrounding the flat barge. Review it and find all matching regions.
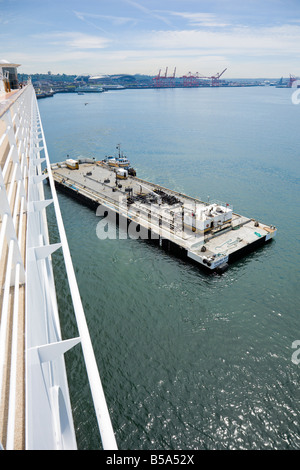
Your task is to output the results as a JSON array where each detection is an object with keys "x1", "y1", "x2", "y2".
[{"x1": 39, "y1": 87, "x2": 300, "y2": 450}]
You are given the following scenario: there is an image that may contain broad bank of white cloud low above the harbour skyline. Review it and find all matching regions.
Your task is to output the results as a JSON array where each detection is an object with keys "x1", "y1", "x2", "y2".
[{"x1": 12, "y1": 7, "x2": 300, "y2": 78}]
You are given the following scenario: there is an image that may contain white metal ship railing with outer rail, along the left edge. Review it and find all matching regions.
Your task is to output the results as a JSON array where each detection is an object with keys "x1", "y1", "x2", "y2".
[{"x1": 0, "y1": 84, "x2": 117, "y2": 449}]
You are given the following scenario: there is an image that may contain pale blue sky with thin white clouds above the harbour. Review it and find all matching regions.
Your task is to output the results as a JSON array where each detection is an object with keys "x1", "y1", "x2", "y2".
[{"x1": 0, "y1": 0, "x2": 300, "y2": 78}]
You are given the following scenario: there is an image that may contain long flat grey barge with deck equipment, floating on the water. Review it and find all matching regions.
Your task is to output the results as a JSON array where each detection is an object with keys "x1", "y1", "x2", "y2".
[{"x1": 51, "y1": 158, "x2": 277, "y2": 273}]
